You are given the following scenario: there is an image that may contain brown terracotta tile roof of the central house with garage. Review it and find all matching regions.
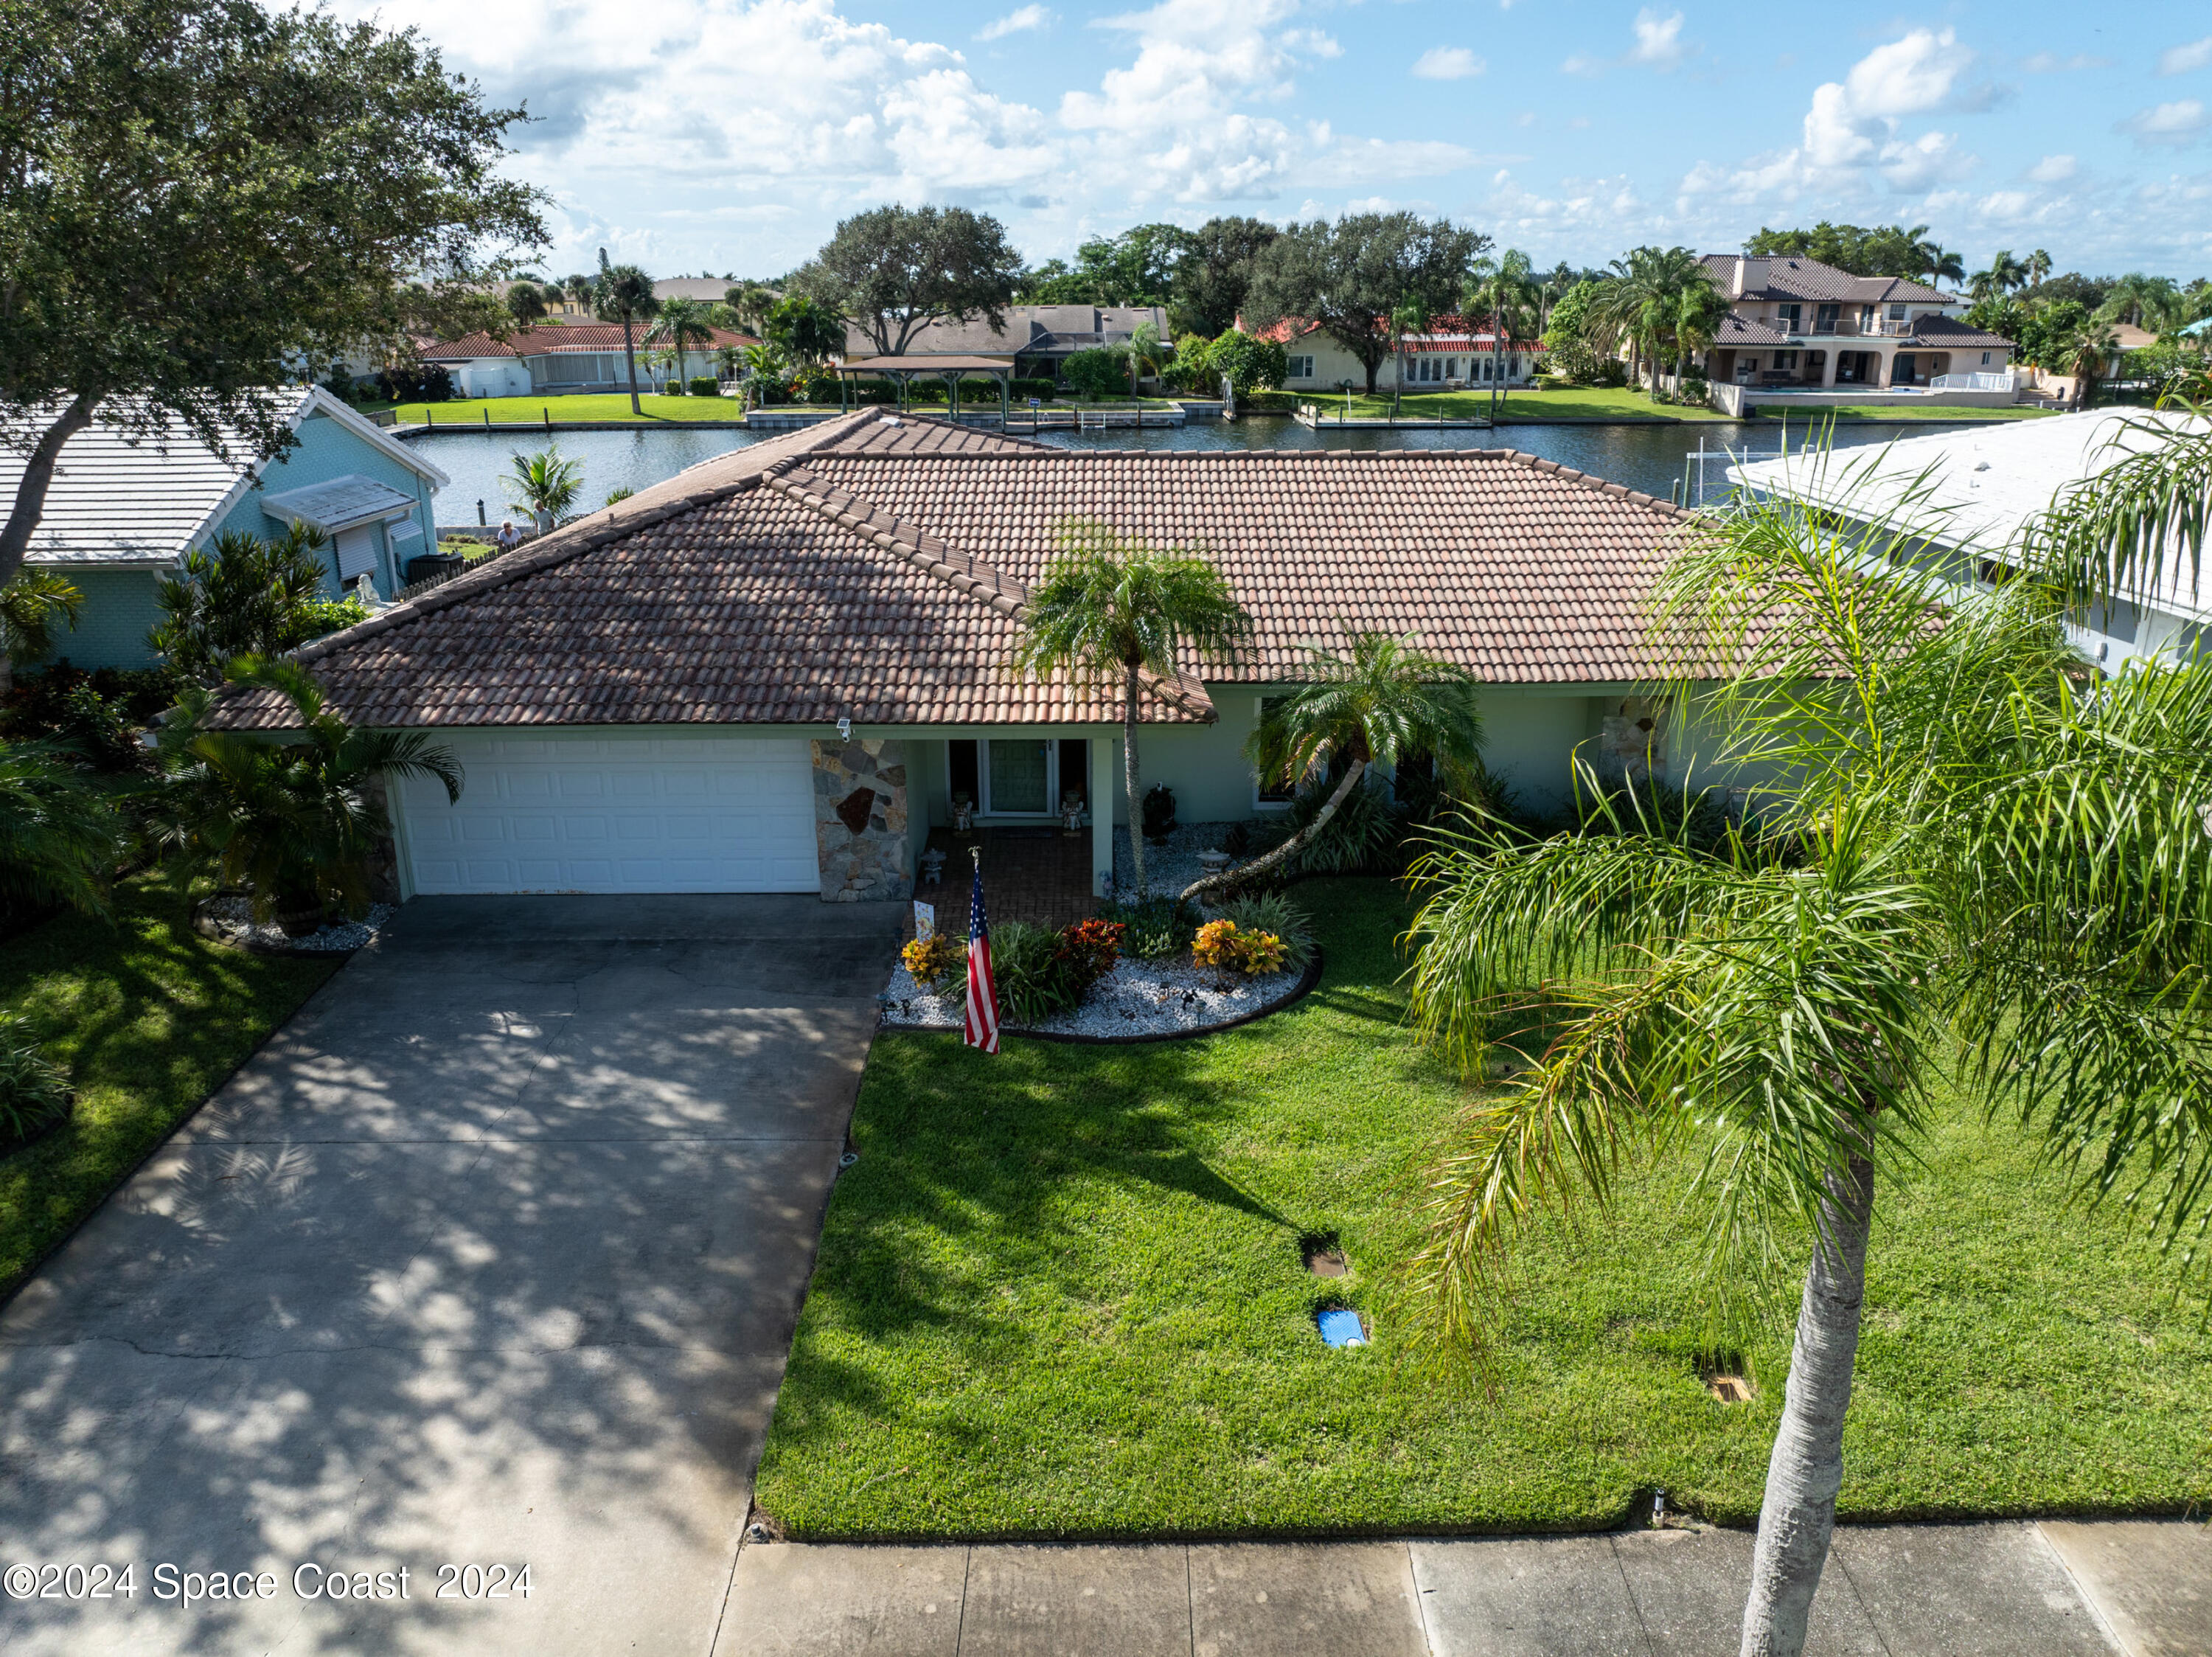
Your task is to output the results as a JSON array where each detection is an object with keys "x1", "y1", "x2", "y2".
[{"x1": 208, "y1": 409, "x2": 1686, "y2": 728}]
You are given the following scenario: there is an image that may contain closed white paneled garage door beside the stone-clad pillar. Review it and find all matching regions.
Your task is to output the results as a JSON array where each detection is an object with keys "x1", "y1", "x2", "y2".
[{"x1": 398, "y1": 730, "x2": 821, "y2": 894}]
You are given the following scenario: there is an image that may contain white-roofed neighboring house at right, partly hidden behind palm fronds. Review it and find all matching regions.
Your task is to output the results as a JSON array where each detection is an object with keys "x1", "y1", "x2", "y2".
[{"x1": 1728, "y1": 409, "x2": 2212, "y2": 670}]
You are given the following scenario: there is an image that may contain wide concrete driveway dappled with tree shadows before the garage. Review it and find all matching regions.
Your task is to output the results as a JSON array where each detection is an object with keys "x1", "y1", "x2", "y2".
[{"x1": 0, "y1": 898, "x2": 896, "y2": 1655}]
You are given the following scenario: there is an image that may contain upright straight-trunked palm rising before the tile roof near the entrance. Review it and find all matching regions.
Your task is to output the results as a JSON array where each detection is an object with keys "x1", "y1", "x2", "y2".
[{"x1": 1013, "y1": 520, "x2": 1252, "y2": 898}]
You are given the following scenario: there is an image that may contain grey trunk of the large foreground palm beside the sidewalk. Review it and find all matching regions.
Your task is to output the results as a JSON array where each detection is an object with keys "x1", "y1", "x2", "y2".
[{"x1": 1741, "y1": 1157, "x2": 1874, "y2": 1657}]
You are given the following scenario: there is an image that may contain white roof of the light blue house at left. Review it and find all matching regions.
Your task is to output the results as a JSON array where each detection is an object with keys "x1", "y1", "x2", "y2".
[{"x1": 0, "y1": 387, "x2": 447, "y2": 566}]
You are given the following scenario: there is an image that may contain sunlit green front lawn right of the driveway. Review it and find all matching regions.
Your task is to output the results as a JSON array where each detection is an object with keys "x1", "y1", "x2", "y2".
[{"x1": 759, "y1": 880, "x2": 2212, "y2": 1540}]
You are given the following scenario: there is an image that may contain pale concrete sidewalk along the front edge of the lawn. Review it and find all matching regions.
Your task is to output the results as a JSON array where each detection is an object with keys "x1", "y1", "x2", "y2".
[{"x1": 714, "y1": 1520, "x2": 2212, "y2": 1657}]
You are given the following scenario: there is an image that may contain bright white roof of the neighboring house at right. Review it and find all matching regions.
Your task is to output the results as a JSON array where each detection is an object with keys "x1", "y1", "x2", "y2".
[{"x1": 1728, "y1": 409, "x2": 2212, "y2": 613}]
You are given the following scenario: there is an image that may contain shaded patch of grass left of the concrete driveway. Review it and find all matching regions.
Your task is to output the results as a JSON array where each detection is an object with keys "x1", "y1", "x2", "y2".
[{"x1": 0, "y1": 858, "x2": 338, "y2": 1296}]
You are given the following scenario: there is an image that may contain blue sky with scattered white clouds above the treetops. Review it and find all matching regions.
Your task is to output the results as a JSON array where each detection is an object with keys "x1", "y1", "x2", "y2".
[{"x1": 334, "y1": 0, "x2": 2212, "y2": 279}]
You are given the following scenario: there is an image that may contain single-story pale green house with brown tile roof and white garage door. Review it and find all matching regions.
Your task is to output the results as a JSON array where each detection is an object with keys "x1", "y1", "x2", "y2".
[{"x1": 199, "y1": 409, "x2": 1683, "y2": 898}]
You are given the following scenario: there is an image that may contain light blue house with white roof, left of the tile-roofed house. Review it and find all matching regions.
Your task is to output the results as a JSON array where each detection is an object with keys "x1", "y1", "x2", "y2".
[{"x1": 0, "y1": 387, "x2": 447, "y2": 668}]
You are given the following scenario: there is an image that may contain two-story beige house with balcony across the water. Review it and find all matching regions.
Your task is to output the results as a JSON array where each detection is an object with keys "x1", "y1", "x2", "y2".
[{"x1": 1661, "y1": 252, "x2": 2013, "y2": 392}]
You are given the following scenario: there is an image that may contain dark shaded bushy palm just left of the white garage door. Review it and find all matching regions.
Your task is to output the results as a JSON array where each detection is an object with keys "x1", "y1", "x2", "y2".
[{"x1": 157, "y1": 657, "x2": 462, "y2": 931}]
